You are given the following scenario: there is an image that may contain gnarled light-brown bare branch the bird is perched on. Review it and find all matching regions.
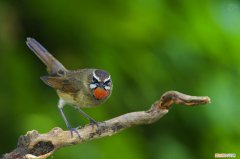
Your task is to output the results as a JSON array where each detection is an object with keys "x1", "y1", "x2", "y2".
[{"x1": 2, "y1": 91, "x2": 210, "y2": 159}]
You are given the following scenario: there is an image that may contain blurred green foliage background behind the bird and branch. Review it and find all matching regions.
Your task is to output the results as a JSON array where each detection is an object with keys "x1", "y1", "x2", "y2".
[{"x1": 0, "y1": 0, "x2": 240, "y2": 159}]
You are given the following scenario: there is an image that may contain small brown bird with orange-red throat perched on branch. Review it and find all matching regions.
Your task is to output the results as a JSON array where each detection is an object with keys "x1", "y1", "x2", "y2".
[{"x1": 26, "y1": 37, "x2": 113, "y2": 138}]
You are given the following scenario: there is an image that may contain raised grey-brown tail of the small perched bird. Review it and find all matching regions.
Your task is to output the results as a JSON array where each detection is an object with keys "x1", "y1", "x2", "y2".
[{"x1": 26, "y1": 37, "x2": 66, "y2": 75}]
